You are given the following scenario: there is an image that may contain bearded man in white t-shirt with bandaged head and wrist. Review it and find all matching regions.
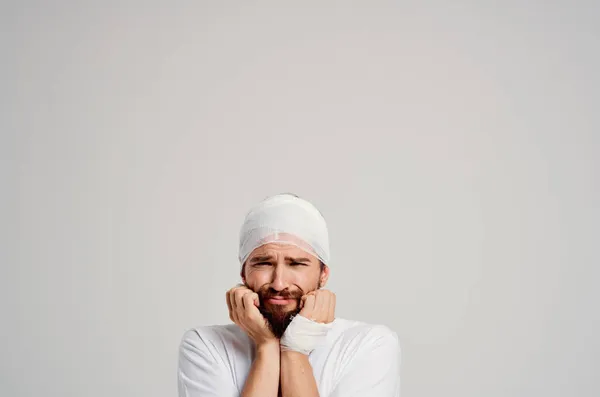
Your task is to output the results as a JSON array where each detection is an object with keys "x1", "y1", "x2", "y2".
[{"x1": 178, "y1": 194, "x2": 400, "y2": 397}]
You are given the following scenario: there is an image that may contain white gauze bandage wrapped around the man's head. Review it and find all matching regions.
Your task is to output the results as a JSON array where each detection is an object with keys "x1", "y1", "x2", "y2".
[{"x1": 238, "y1": 194, "x2": 329, "y2": 265}]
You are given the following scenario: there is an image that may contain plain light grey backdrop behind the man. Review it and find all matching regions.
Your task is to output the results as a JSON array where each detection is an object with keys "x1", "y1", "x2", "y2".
[{"x1": 0, "y1": 0, "x2": 600, "y2": 397}]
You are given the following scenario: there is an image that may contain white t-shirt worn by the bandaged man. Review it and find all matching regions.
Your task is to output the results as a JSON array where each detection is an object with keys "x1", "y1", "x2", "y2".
[{"x1": 178, "y1": 318, "x2": 400, "y2": 397}]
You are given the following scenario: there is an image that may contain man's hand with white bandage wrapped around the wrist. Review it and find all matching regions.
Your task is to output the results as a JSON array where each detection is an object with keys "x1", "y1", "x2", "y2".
[{"x1": 280, "y1": 290, "x2": 335, "y2": 355}]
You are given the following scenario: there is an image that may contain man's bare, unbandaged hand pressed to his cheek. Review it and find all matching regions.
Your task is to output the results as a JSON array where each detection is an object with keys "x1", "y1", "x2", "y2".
[{"x1": 226, "y1": 285, "x2": 279, "y2": 346}]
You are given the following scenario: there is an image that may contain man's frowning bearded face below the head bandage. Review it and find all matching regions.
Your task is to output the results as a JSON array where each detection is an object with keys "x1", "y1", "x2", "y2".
[{"x1": 242, "y1": 243, "x2": 329, "y2": 338}]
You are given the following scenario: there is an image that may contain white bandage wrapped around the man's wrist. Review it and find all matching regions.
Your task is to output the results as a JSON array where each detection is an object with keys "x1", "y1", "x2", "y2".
[{"x1": 279, "y1": 315, "x2": 333, "y2": 355}]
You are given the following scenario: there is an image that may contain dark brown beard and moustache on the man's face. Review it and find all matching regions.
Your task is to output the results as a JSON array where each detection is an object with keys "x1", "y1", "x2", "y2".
[{"x1": 257, "y1": 287, "x2": 304, "y2": 339}]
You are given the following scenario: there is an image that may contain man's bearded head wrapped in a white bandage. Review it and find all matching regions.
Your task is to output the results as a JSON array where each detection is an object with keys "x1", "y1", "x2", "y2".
[{"x1": 240, "y1": 194, "x2": 329, "y2": 337}]
